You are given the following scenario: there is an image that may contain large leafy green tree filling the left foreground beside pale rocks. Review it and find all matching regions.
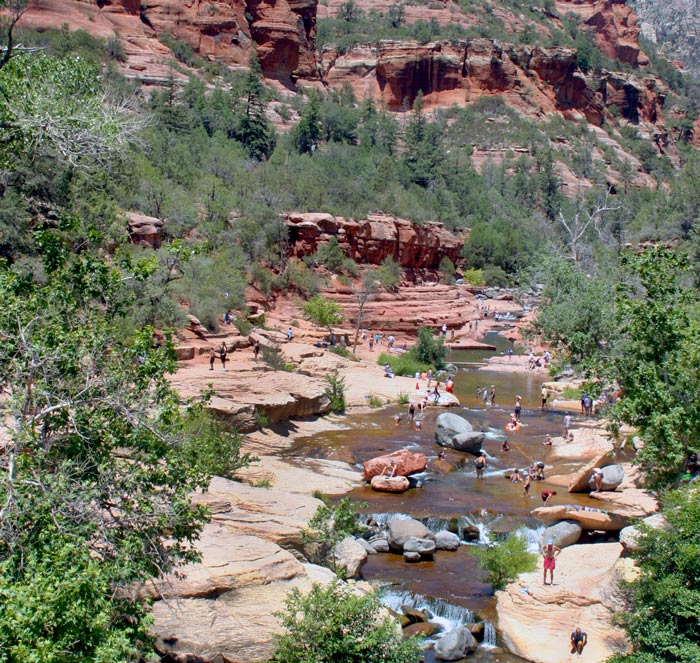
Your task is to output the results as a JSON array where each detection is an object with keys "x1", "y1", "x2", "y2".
[{"x1": 0, "y1": 243, "x2": 243, "y2": 663}]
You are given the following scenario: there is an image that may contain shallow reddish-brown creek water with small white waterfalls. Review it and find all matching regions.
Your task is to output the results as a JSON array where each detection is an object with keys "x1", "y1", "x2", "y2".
[{"x1": 291, "y1": 333, "x2": 620, "y2": 663}]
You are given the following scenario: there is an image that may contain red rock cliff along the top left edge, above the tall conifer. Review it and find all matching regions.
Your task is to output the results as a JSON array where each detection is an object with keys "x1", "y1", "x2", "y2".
[{"x1": 17, "y1": 0, "x2": 318, "y2": 79}]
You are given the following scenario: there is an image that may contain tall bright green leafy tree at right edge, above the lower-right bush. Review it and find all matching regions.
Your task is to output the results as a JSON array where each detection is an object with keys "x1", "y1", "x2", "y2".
[{"x1": 601, "y1": 247, "x2": 700, "y2": 487}]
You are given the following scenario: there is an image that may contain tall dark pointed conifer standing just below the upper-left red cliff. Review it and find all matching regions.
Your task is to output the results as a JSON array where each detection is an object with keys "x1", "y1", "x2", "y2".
[{"x1": 233, "y1": 49, "x2": 276, "y2": 159}]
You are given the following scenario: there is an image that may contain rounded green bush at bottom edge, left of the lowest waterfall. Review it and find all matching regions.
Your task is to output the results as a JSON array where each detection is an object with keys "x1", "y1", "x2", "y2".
[{"x1": 275, "y1": 582, "x2": 421, "y2": 663}]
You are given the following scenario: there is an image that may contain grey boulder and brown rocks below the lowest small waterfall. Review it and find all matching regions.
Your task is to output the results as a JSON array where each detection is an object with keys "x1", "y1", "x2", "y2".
[{"x1": 391, "y1": 605, "x2": 484, "y2": 661}]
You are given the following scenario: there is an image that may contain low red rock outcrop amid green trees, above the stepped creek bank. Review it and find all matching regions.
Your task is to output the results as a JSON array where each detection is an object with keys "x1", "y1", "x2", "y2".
[{"x1": 286, "y1": 213, "x2": 463, "y2": 269}]
